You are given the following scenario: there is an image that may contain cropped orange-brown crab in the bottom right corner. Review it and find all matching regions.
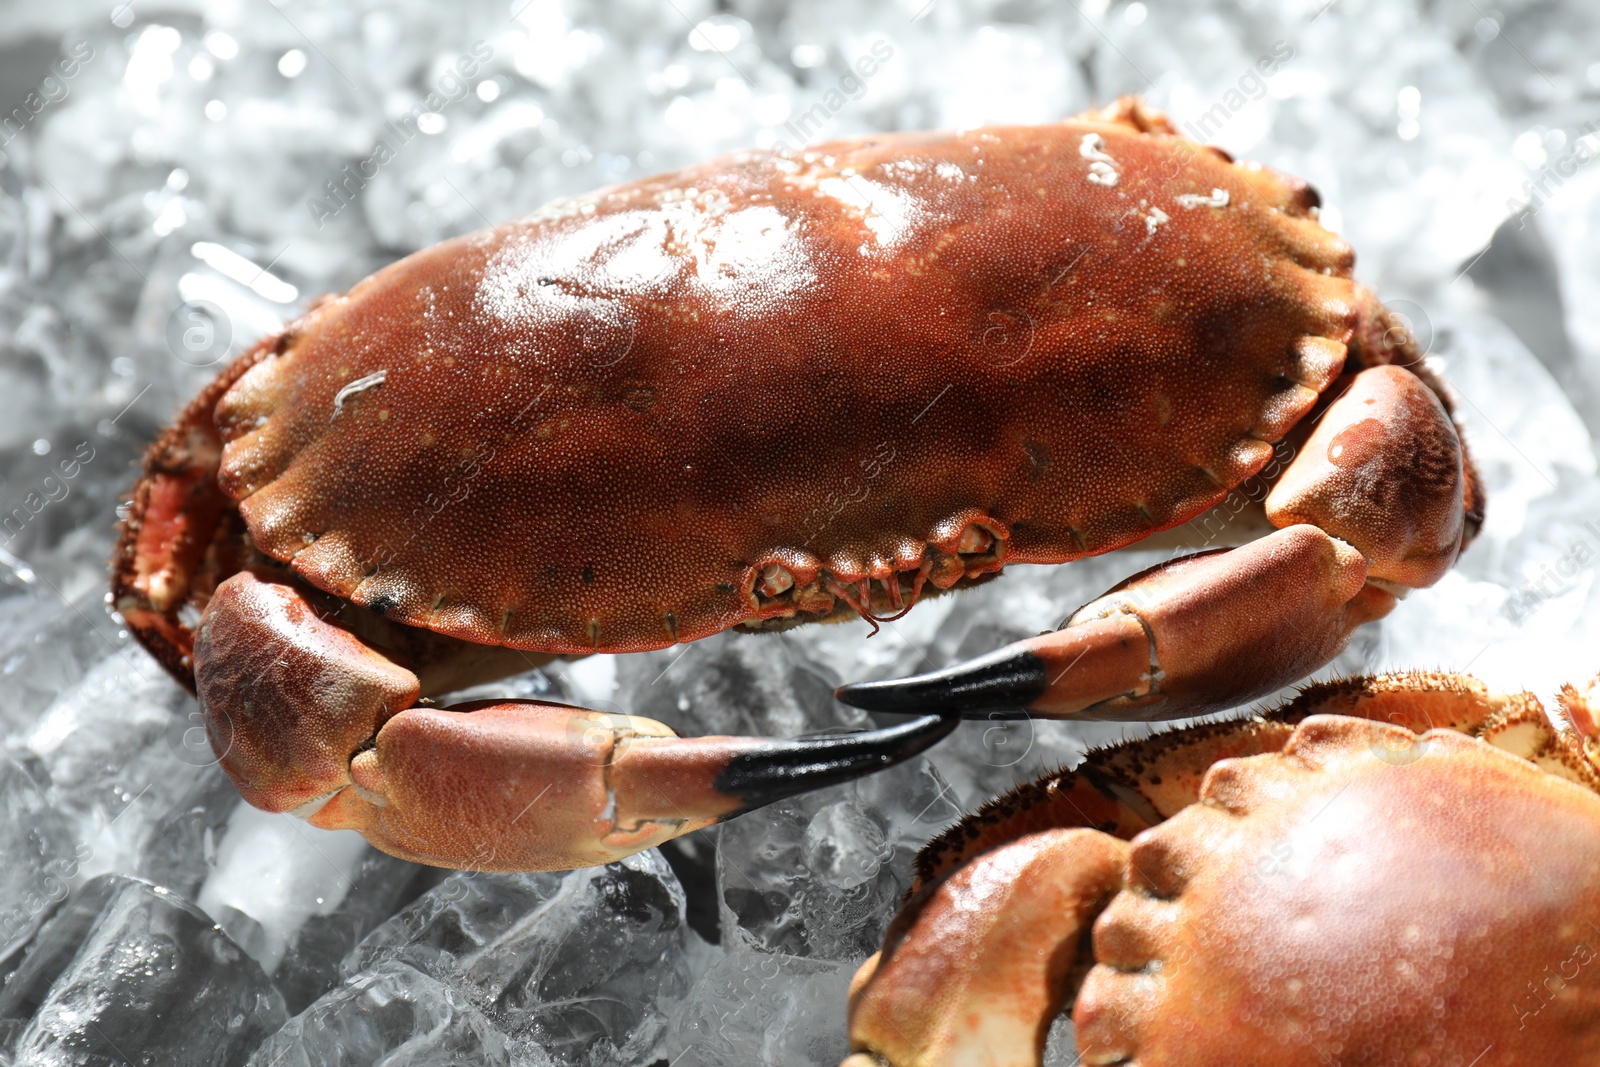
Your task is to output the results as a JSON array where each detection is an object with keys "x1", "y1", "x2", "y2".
[{"x1": 846, "y1": 673, "x2": 1600, "y2": 1067}]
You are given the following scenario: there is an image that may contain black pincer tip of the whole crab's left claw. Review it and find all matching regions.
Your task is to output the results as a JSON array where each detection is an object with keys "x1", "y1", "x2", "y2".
[{"x1": 714, "y1": 715, "x2": 962, "y2": 819}]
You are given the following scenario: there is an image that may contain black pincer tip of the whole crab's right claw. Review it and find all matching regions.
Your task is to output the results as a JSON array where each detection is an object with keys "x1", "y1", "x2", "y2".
[{"x1": 834, "y1": 648, "x2": 1048, "y2": 718}]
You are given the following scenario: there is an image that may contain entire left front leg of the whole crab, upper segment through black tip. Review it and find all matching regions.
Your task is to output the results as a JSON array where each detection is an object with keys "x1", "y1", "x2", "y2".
[{"x1": 195, "y1": 571, "x2": 957, "y2": 870}]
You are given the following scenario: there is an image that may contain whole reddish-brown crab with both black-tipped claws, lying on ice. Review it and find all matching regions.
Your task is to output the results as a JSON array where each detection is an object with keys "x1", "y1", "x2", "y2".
[{"x1": 112, "y1": 99, "x2": 1480, "y2": 869}]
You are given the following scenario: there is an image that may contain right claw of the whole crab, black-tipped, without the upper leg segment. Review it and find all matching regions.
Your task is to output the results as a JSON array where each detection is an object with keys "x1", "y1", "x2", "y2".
[{"x1": 837, "y1": 525, "x2": 1395, "y2": 720}]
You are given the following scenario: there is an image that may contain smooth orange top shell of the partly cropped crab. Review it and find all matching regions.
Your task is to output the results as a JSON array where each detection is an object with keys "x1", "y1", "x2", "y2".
[{"x1": 1074, "y1": 717, "x2": 1600, "y2": 1067}]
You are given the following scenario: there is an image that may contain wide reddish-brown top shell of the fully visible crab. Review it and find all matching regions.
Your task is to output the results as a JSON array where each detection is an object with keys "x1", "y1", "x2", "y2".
[{"x1": 218, "y1": 104, "x2": 1355, "y2": 653}]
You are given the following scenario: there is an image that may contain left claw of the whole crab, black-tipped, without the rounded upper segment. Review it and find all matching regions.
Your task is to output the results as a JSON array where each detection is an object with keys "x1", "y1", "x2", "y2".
[{"x1": 310, "y1": 701, "x2": 957, "y2": 870}]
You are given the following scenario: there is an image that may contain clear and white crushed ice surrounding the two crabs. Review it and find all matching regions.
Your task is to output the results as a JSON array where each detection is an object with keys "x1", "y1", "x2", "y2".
[{"x1": 0, "y1": 0, "x2": 1600, "y2": 1067}]
